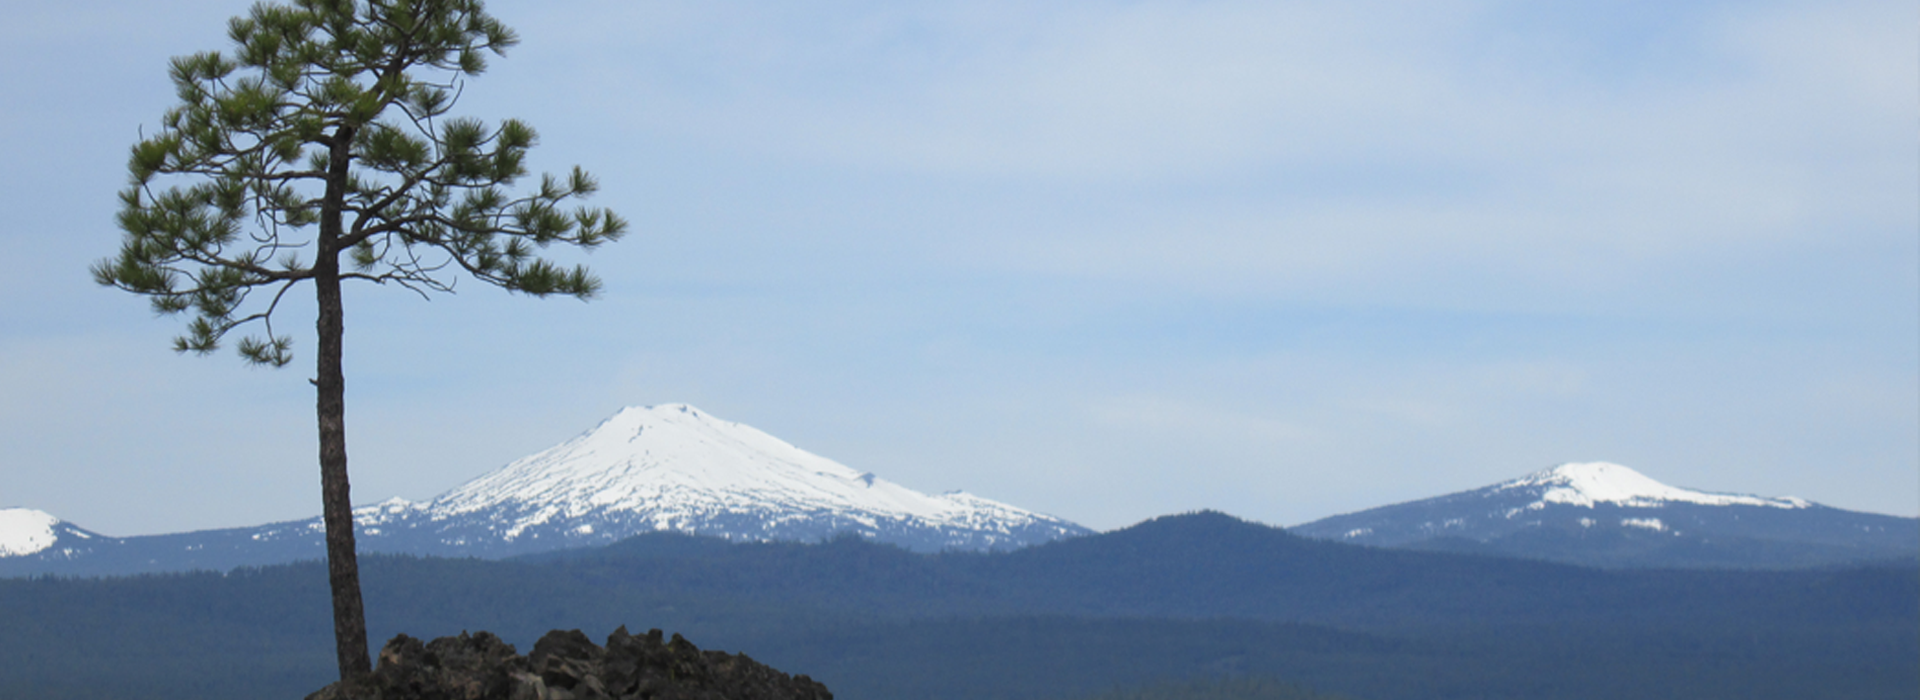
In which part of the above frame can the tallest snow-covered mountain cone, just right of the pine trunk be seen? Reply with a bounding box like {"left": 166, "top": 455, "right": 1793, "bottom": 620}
{"left": 332, "top": 405, "right": 1087, "bottom": 554}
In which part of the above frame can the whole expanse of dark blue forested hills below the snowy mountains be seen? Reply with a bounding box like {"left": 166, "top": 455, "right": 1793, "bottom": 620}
{"left": 0, "top": 514, "right": 1920, "bottom": 700}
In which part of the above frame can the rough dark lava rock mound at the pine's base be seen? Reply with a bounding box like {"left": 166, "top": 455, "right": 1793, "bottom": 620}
{"left": 307, "top": 627, "right": 833, "bottom": 700}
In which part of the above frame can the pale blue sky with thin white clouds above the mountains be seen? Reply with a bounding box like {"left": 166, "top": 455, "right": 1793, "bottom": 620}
{"left": 0, "top": 0, "right": 1920, "bottom": 535}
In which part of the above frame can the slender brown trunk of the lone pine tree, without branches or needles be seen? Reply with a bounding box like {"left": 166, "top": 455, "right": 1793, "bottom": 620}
{"left": 313, "top": 128, "right": 372, "bottom": 681}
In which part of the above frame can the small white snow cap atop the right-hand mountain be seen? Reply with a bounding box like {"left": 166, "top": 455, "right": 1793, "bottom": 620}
{"left": 1494, "top": 462, "right": 1811, "bottom": 508}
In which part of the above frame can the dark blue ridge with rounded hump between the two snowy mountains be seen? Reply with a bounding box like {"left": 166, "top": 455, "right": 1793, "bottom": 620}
{"left": 515, "top": 512, "right": 1920, "bottom": 627}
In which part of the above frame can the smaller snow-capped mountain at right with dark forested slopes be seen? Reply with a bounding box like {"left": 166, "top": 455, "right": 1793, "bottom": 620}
{"left": 1290, "top": 462, "right": 1920, "bottom": 568}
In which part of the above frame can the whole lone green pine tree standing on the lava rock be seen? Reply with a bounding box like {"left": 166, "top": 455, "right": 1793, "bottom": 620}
{"left": 92, "top": 0, "right": 626, "bottom": 679}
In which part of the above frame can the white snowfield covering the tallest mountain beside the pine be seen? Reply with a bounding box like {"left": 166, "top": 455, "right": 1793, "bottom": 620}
{"left": 355, "top": 403, "right": 1058, "bottom": 539}
